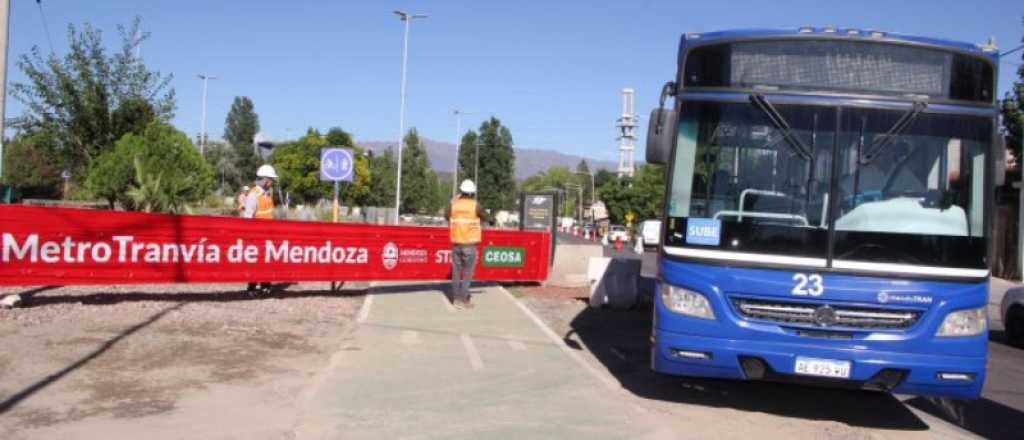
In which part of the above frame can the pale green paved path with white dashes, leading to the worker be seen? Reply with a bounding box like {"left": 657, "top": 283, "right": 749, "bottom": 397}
{"left": 295, "top": 284, "right": 650, "bottom": 439}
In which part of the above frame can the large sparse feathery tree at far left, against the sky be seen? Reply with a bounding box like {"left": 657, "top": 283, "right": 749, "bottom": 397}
{"left": 11, "top": 17, "right": 175, "bottom": 175}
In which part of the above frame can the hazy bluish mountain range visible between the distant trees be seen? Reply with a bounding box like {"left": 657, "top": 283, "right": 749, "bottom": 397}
{"left": 359, "top": 137, "right": 618, "bottom": 180}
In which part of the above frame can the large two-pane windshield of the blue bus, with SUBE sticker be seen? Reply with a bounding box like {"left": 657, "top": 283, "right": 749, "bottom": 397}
{"left": 666, "top": 99, "right": 991, "bottom": 268}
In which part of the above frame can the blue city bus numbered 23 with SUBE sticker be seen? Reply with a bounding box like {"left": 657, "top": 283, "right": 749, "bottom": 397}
{"left": 646, "top": 28, "right": 1006, "bottom": 398}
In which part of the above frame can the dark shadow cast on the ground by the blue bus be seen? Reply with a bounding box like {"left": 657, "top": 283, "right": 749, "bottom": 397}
{"left": 565, "top": 304, "right": 928, "bottom": 431}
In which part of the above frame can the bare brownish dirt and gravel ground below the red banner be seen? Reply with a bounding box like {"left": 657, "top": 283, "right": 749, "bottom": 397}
{"left": 0, "top": 283, "right": 366, "bottom": 440}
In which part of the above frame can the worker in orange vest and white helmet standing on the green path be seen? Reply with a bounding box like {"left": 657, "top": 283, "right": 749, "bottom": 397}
{"left": 447, "top": 179, "right": 484, "bottom": 310}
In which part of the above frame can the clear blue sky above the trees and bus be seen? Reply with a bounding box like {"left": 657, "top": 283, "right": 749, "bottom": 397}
{"left": 7, "top": 0, "right": 1024, "bottom": 160}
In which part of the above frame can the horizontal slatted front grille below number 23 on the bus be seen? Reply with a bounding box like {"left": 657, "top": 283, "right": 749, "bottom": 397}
{"left": 732, "top": 298, "right": 921, "bottom": 329}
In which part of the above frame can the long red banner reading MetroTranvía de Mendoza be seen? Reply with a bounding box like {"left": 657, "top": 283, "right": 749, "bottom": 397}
{"left": 0, "top": 205, "right": 551, "bottom": 285}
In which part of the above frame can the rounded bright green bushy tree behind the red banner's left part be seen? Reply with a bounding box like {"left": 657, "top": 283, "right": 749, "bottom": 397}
{"left": 86, "top": 121, "right": 213, "bottom": 212}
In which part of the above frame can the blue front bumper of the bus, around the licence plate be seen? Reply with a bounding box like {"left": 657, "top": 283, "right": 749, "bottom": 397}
{"left": 651, "top": 329, "right": 985, "bottom": 399}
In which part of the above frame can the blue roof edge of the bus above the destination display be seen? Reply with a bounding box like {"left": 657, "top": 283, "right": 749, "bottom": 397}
{"left": 679, "top": 27, "right": 999, "bottom": 62}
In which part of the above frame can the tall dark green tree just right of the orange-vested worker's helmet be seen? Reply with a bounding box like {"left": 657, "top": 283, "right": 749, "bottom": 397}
{"left": 474, "top": 117, "right": 516, "bottom": 211}
